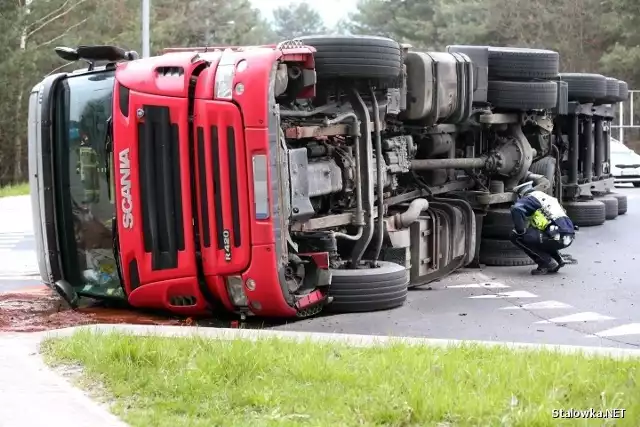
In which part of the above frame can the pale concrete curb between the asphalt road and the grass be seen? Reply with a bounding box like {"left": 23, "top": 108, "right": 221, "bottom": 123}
{"left": 36, "top": 324, "right": 640, "bottom": 359}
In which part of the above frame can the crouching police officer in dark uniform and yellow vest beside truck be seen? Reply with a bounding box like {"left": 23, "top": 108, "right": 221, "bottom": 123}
{"left": 511, "top": 181, "right": 575, "bottom": 275}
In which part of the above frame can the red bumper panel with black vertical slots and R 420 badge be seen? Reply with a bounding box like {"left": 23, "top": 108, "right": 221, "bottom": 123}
{"left": 194, "top": 100, "right": 252, "bottom": 276}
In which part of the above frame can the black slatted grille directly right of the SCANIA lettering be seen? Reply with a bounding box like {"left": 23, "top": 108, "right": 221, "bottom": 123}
{"left": 138, "top": 105, "right": 185, "bottom": 270}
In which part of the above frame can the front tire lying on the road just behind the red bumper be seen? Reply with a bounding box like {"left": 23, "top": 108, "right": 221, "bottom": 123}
{"left": 326, "top": 261, "right": 409, "bottom": 313}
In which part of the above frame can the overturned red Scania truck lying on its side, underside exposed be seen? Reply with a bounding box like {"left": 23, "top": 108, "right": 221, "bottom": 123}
{"left": 29, "top": 36, "right": 622, "bottom": 317}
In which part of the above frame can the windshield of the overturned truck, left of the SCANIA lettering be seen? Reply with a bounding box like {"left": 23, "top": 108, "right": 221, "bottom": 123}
{"left": 54, "top": 71, "right": 124, "bottom": 298}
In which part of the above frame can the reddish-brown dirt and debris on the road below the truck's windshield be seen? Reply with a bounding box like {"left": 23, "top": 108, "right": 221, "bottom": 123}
{"left": 0, "top": 288, "right": 192, "bottom": 332}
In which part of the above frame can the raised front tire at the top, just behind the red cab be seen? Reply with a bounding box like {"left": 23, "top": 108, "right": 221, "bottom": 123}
{"left": 297, "top": 36, "right": 402, "bottom": 81}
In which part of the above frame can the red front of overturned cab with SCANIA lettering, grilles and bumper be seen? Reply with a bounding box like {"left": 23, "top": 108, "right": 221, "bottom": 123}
{"left": 112, "top": 47, "right": 330, "bottom": 316}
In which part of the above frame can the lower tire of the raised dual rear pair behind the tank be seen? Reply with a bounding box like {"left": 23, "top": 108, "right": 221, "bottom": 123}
{"left": 487, "top": 80, "right": 558, "bottom": 111}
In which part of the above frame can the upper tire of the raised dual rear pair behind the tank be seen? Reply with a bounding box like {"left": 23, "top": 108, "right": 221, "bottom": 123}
{"left": 489, "top": 47, "right": 560, "bottom": 80}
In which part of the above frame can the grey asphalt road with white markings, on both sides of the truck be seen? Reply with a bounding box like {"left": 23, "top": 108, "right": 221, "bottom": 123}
{"left": 5, "top": 188, "right": 640, "bottom": 348}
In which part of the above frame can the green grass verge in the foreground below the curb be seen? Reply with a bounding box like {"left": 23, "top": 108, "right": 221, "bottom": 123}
{"left": 43, "top": 331, "right": 640, "bottom": 427}
